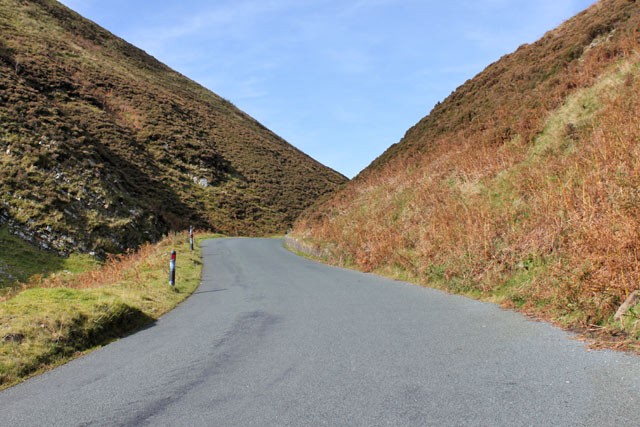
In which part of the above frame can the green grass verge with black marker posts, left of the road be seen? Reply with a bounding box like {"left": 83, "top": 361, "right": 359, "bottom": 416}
{"left": 0, "top": 234, "right": 214, "bottom": 389}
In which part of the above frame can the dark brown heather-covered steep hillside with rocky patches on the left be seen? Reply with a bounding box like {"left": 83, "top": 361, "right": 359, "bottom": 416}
{"left": 0, "top": 0, "right": 346, "bottom": 258}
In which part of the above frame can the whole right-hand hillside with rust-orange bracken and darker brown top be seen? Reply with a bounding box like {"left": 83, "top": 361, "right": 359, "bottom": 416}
{"left": 293, "top": 0, "right": 640, "bottom": 346}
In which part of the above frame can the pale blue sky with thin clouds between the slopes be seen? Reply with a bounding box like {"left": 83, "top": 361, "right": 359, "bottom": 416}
{"left": 62, "top": 0, "right": 595, "bottom": 177}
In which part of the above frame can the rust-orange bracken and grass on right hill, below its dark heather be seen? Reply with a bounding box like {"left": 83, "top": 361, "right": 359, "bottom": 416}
{"left": 291, "top": 50, "right": 640, "bottom": 353}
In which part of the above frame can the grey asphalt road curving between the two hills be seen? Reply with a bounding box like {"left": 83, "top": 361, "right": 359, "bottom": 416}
{"left": 0, "top": 239, "right": 640, "bottom": 427}
